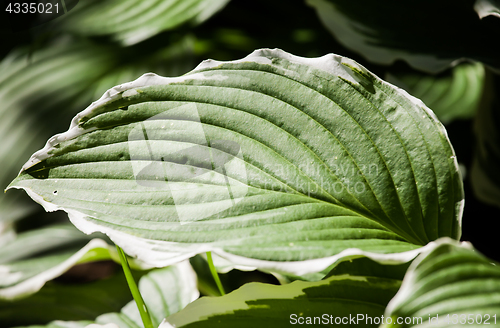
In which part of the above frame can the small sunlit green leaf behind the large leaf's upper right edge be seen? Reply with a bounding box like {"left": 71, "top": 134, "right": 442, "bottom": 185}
{"left": 387, "top": 63, "right": 485, "bottom": 124}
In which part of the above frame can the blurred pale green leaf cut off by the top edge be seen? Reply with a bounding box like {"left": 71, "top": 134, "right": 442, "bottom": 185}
{"left": 58, "top": 0, "right": 229, "bottom": 45}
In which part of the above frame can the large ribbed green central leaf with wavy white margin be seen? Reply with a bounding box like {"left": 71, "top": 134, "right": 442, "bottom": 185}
{"left": 10, "top": 50, "right": 463, "bottom": 274}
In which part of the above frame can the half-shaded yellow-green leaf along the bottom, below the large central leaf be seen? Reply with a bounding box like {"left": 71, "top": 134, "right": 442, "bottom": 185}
{"left": 160, "top": 262, "right": 401, "bottom": 328}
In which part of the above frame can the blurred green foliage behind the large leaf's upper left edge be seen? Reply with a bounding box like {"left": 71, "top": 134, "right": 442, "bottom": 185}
{"left": 0, "top": 36, "right": 194, "bottom": 228}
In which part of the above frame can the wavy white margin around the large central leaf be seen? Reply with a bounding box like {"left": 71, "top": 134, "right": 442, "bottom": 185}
{"left": 6, "top": 49, "right": 464, "bottom": 275}
